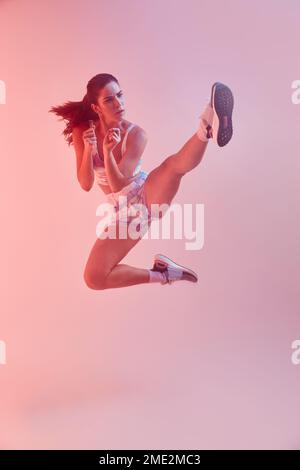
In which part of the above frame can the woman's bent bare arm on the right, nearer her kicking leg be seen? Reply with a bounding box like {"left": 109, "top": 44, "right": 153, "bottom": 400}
{"left": 103, "top": 127, "right": 147, "bottom": 192}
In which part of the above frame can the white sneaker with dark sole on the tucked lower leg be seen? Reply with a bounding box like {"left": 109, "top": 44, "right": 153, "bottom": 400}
{"left": 152, "top": 255, "right": 198, "bottom": 284}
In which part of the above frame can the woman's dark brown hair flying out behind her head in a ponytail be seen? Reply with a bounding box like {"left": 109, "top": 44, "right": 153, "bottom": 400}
{"left": 49, "top": 73, "right": 119, "bottom": 145}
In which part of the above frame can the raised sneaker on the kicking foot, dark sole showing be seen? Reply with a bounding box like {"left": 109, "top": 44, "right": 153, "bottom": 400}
{"left": 211, "top": 82, "right": 234, "bottom": 147}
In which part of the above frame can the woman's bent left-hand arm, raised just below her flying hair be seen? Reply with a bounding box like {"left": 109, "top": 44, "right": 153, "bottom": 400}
{"left": 72, "top": 126, "right": 94, "bottom": 191}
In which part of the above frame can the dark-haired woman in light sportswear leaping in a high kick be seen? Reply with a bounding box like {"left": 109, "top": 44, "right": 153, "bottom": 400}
{"left": 50, "top": 73, "right": 233, "bottom": 289}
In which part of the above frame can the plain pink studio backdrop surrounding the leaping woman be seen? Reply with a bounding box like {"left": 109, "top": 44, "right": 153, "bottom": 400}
{"left": 0, "top": 0, "right": 300, "bottom": 449}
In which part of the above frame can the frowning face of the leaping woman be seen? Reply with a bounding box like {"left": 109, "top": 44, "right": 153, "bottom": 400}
{"left": 94, "top": 82, "right": 125, "bottom": 123}
